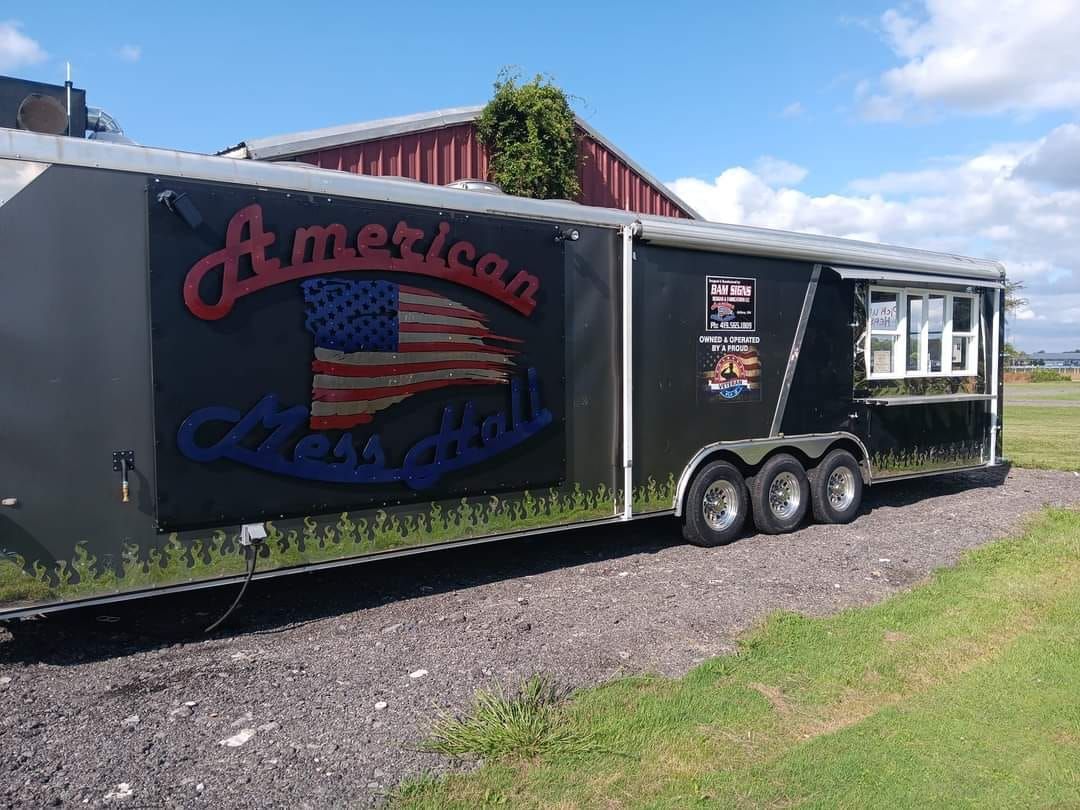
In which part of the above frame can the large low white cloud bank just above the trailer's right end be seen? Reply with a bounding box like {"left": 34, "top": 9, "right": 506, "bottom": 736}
{"left": 669, "top": 127, "right": 1080, "bottom": 350}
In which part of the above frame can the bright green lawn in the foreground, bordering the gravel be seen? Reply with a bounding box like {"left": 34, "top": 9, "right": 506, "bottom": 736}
{"left": 392, "top": 510, "right": 1080, "bottom": 809}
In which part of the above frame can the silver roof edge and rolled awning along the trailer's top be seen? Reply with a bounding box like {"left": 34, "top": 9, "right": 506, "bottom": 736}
{"left": 0, "top": 129, "right": 1004, "bottom": 281}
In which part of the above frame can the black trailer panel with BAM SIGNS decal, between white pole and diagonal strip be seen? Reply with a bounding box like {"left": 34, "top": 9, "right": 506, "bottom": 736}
{"left": 634, "top": 245, "right": 812, "bottom": 512}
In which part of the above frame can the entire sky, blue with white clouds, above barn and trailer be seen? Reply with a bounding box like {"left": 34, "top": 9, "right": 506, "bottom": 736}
{"left": 0, "top": 0, "right": 1080, "bottom": 349}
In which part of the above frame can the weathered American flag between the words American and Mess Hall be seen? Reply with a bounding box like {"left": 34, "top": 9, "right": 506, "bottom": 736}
{"left": 300, "top": 279, "right": 521, "bottom": 430}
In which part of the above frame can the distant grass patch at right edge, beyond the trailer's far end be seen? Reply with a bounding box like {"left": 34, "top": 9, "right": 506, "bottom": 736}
{"left": 1004, "top": 405, "right": 1080, "bottom": 470}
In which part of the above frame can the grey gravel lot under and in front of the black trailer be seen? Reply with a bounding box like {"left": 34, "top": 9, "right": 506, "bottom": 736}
{"left": 0, "top": 470, "right": 1080, "bottom": 808}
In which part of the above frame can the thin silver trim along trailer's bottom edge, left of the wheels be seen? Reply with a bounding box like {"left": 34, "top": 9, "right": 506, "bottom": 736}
{"left": 0, "top": 509, "right": 672, "bottom": 622}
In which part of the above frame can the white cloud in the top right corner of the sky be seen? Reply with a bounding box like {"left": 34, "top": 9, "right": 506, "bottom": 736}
{"left": 856, "top": 0, "right": 1080, "bottom": 121}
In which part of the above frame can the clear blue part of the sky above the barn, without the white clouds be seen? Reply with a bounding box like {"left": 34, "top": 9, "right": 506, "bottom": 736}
{"left": 4, "top": 2, "right": 1061, "bottom": 185}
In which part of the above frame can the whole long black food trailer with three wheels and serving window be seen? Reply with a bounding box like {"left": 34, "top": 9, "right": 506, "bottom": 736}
{"left": 0, "top": 130, "right": 1003, "bottom": 618}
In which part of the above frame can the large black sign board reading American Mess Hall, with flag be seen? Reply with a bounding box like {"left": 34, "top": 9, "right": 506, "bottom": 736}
{"left": 150, "top": 181, "right": 565, "bottom": 528}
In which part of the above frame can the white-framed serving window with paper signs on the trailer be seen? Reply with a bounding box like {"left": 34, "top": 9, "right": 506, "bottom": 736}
{"left": 866, "top": 286, "right": 978, "bottom": 380}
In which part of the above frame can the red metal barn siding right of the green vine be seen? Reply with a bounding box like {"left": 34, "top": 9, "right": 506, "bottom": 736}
{"left": 578, "top": 133, "right": 690, "bottom": 218}
